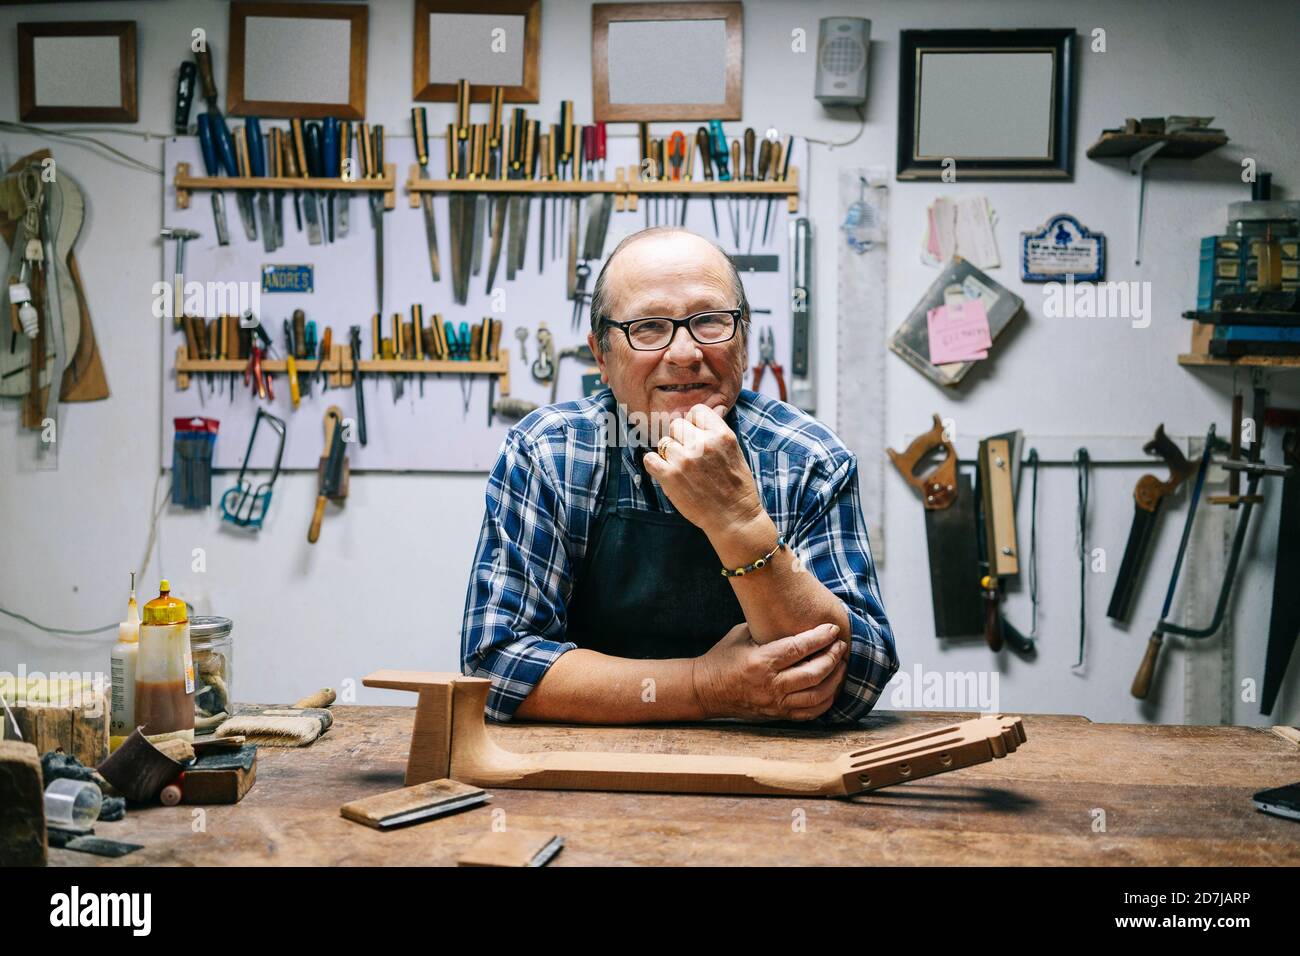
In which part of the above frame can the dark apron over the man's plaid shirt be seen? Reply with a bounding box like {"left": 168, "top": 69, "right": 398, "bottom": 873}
{"left": 566, "top": 410, "right": 745, "bottom": 659}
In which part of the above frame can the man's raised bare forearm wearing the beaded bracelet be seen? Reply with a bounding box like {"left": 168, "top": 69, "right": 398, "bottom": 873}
{"left": 709, "top": 512, "right": 852, "bottom": 644}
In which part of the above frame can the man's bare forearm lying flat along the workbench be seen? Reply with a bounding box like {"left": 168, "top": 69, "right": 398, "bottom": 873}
{"left": 515, "top": 648, "right": 710, "bottom": 723}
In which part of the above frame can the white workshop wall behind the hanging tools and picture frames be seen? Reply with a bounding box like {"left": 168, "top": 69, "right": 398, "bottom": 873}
{"left": 0, "top": 0, "right": 1300, "bottom": 723}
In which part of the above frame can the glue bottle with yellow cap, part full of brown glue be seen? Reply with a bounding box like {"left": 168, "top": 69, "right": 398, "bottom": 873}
{"left": 135, "top": 581, "right": 194, "bottom": 741}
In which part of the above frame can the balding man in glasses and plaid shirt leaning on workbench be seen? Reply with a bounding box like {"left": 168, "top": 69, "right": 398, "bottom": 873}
{"left": 462, "top": 228, "right": 898, "bottom": 723}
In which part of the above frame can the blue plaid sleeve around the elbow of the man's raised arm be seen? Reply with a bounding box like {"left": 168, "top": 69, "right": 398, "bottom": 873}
{"left": 790, "top": 451, "right": 898, "bottom": 723}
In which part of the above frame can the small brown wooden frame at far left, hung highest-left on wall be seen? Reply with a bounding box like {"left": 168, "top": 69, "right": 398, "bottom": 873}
{"left": 18, "top": 20, "right": 139, "bottom": 122}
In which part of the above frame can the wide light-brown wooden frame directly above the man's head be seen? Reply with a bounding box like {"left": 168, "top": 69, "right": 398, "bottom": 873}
{"left": 592, "top": 3, "right": 745, "bottom": 122}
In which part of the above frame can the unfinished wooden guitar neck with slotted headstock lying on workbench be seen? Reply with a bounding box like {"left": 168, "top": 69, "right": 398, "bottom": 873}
{"left": 361, "top": 671, "right": 1024, "bottom": 796}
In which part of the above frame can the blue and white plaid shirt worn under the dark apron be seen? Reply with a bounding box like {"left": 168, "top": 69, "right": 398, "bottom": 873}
{"left": 460, "top": 388, "right": 898, "bottom": 723}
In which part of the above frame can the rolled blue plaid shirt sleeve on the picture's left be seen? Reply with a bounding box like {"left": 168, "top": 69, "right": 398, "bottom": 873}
{"left": 460, "top": 431, "right": 577, "bottom": 721}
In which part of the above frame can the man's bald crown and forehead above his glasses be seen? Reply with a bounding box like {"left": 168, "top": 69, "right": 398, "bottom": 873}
{"left": 592, "top": 226, "right": 749, "bottom": 351}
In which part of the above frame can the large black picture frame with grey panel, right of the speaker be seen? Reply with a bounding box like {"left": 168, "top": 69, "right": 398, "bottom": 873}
{"left": 897, "top": 29, "right": 1075, "bottom": 179}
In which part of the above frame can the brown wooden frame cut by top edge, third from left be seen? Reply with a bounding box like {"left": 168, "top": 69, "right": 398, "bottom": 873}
{"left": 411, "top": 0, "right": 542, "bottom": 103}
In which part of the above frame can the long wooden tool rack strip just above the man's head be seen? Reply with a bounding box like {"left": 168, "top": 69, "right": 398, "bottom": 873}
{"left": 403, "top": 165, "right": 800, "bottom": 215}
